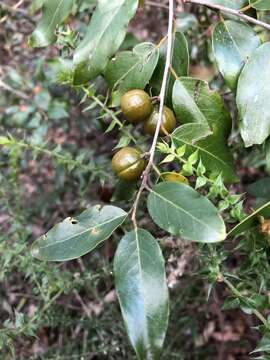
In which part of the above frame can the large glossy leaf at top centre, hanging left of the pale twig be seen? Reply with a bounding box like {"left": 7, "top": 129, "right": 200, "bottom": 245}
{"left": 73, "top": 0, "right": 138, "bottom": 85}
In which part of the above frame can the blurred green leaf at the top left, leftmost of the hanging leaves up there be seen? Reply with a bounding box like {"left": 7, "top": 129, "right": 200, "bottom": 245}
{"left": 29, "top": 0, "right": 73, "bottom": 47}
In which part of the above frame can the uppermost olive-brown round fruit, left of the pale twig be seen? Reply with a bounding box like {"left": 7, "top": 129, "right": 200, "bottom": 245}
{"left": 121, "top": 90, "right": 153, "bottom": 123}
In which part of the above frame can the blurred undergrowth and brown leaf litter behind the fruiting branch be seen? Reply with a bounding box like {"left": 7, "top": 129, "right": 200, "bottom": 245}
{"left": 0, "top": 0, "right": 270, "bottom": 360}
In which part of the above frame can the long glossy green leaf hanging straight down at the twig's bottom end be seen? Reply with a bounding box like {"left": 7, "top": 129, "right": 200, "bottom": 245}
{"left": 114, "top": 229, "right": 169, "bottom": 360}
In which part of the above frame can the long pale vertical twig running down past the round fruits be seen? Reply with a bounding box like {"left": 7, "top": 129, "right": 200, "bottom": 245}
{"left": 131, "top": 0, "right": 174, "bottom": 228}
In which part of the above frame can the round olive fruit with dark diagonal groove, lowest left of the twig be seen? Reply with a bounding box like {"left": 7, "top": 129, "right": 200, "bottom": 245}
{"left": 112, "top": 147, "right": 145, "bottom": 181}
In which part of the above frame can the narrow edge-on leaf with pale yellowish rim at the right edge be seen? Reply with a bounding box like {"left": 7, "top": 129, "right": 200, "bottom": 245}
{"left": 228, "top": 201, "right": 270, "bottom": 236}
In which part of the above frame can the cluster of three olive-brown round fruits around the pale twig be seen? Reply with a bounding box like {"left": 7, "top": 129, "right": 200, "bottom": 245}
{"left": 112, "top": 89, "right": 176, "bottom": 181}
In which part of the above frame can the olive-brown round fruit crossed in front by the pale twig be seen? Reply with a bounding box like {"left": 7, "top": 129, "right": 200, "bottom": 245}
{"left": 144, "top": 106, "right": 176, "bottom": 136}
